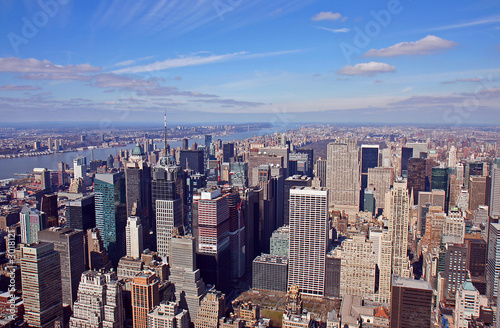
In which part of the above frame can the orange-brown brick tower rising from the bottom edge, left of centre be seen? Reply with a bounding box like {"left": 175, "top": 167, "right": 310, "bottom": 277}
{"left": 132, "top": 271, "right": 160, "bottom": 328}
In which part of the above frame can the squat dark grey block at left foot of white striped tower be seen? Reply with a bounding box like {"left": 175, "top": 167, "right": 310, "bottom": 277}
{"left": 252, "top": 254, "right": 288, "bottom": 292}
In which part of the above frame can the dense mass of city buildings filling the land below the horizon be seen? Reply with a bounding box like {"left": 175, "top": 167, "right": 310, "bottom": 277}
{"left": 0, "top": 125, "right": 500, "bottom": 328}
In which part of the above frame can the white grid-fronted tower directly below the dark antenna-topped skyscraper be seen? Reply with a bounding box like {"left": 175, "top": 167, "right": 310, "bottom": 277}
{"left": 156, "top": 198, "right": 182, "bottom": 258}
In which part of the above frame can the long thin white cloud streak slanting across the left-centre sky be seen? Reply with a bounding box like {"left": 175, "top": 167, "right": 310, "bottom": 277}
{"left": 113, "top": 50, "right": 300, "bottom": 74}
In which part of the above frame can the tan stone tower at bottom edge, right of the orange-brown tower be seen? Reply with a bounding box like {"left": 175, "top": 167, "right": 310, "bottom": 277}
{"left": 194, "top": 289, "right": 226, "bottom": 328}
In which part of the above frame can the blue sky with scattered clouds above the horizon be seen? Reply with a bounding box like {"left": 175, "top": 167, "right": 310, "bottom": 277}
{"left": 0, "top": 0, "right": 500, "bottom": 125}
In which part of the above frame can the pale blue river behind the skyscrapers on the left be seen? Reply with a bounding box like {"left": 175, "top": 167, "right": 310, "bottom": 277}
{"left": 0, "top": 126, "right": 292, "bottom": 180}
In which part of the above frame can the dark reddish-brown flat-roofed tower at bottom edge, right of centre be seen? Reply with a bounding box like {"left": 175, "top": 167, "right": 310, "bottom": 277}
{"left": 390, "top": 275, "right": 432, "bottom": 328}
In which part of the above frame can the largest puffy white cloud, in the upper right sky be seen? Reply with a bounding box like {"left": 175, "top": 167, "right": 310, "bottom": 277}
{"left": 363, "top": 35, "right": 458, "bottom": 57}
